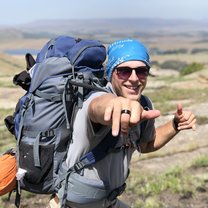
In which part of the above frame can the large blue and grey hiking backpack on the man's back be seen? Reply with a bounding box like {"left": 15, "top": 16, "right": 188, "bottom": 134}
{"left": 5, "top": 36, "right": 106, "bottom": 203}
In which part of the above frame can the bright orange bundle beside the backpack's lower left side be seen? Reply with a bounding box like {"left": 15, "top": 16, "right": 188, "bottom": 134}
{"left": 0, "top": 151, "right": 17, "bottom": 196}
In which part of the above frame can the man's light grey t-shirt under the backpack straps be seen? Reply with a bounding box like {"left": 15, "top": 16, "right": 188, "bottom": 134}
{"left": 66, "top": 82, "right": 155, "bottom": 206}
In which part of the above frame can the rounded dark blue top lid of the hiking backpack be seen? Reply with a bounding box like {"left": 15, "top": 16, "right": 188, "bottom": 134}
{"left": 36, "top": 36, "right": 106, "bottom": 71}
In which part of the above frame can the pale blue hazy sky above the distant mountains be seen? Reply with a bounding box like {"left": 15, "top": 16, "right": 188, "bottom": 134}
{"left": 0, "top": 0, "right": 208, "bottom": 26}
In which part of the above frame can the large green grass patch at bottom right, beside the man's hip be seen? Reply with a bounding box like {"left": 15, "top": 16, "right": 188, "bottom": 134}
{"left": 123, "top": 164, "right": 208, "bottom": 208}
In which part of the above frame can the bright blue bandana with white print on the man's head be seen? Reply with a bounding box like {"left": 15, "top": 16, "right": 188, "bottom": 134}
{"left": 106, "top": 39, "right": 150, "bottom": 81}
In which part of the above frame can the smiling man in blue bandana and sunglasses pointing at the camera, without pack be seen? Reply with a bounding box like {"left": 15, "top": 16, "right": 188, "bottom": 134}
{"left": 49, "top": 39, "right": 196, "bottom": 208}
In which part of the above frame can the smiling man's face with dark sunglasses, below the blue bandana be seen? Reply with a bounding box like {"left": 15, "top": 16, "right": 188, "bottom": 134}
{"left": 111, "top": 61, "right": 148, "bottom": 100}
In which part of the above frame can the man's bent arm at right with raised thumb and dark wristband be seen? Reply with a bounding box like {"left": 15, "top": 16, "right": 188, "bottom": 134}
{"left": 140, "top": 104, "right": 196, "bottom": 153}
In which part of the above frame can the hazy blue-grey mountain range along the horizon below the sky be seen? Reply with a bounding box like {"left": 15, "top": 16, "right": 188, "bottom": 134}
{"left": 0, "top": 18, "right": 208, "bottom": 41}
